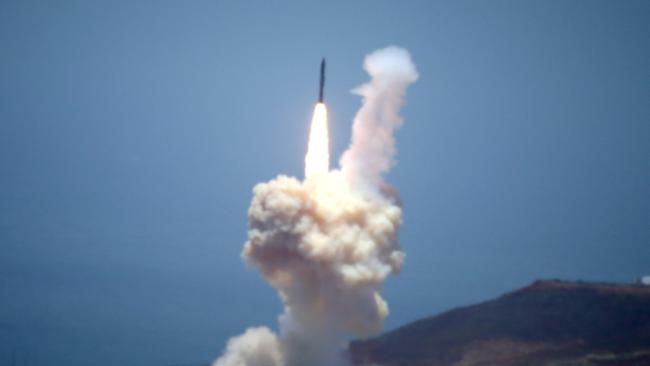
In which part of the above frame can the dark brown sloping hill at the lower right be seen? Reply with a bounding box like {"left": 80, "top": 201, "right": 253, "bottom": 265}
{"left": 351, "top": 281, "right": 650, "bottom": 366}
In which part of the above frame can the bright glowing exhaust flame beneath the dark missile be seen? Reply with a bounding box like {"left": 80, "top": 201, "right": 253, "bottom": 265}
{"left": 305, "top": 103, "right": 330, "bottom": 178}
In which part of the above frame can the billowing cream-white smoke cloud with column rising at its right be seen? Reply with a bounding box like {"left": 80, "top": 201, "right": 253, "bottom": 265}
{"left": 214, "top": 47, "right": 417, "bottom": 366}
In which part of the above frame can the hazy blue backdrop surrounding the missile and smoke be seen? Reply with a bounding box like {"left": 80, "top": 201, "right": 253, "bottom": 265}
{"left": 0, "top": 0, "right": 650, "bottom": 366}
